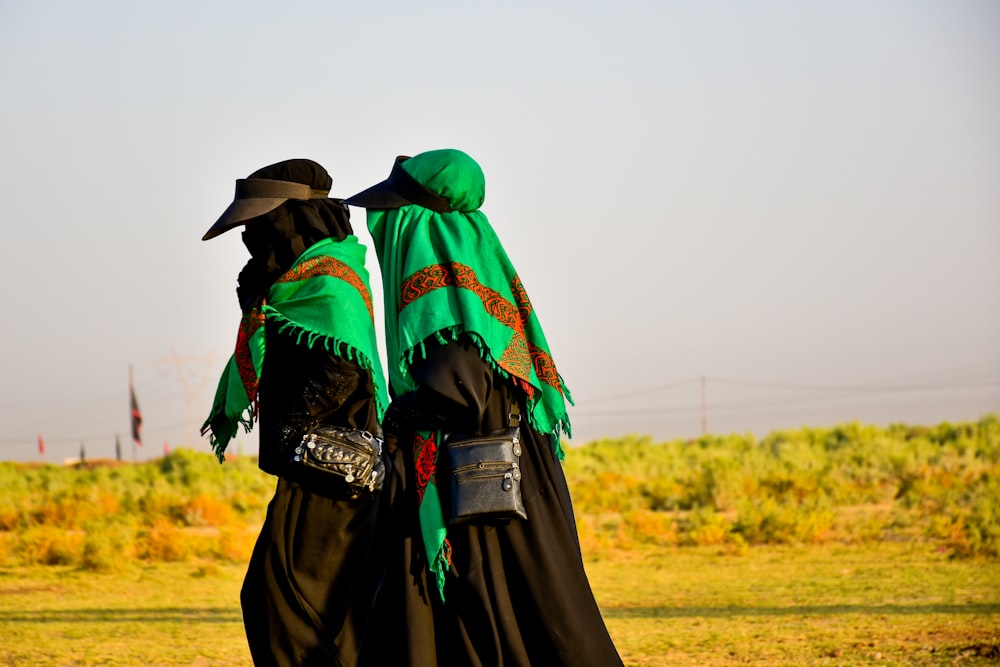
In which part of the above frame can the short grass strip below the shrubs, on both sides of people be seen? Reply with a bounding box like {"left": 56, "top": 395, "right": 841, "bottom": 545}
{"left": 0, "top": 543, "right": 1000, "bottom": 667}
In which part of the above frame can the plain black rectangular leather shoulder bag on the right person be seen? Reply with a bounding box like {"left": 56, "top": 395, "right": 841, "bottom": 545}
{"left": 442, "top": 402, "right": 528, "bottom": 525}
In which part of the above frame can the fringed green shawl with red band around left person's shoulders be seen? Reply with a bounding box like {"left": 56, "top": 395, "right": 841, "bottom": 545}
{"left": 202, "top": 236, "right": 386, "bottom": 462}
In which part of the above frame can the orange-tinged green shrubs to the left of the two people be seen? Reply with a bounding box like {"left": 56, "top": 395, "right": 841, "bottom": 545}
{"left": 0, "top": 449, "right": 274, "bottom": 571}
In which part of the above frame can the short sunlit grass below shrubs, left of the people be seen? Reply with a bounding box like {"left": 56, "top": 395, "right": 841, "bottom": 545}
{"left": 0, "top": 563, "right": 250, "bottom": 667}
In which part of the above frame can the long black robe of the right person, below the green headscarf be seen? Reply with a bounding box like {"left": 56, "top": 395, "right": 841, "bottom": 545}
{"left": 360, "top": 341, "right": 622, "bottom": 667}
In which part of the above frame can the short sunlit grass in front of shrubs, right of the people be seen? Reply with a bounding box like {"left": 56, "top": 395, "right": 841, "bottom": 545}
{"left": 588, "top": 544, "right": 1000, "bottom": 667}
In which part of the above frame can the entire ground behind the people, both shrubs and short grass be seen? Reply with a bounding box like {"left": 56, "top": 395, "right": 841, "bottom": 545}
{"left": 0, "top": 415, "right": 1000, "bottom": 667}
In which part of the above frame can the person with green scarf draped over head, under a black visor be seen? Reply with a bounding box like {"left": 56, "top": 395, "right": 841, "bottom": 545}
{"left": 344, "top": 149, "right": 621, "bottom": 667}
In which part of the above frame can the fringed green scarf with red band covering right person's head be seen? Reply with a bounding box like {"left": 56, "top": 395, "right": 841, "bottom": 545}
{"left": 368, "top": 149, "right": 572, "bottom": 446}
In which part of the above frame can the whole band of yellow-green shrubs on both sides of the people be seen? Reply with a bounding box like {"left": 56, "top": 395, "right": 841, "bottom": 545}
{"left": 0, "top": 415, "right": 1000, "bottom": 570}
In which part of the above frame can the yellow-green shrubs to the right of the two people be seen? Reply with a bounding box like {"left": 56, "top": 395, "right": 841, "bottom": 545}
{"left": 565, "top": 415, "right": 1000, "bottom": 558}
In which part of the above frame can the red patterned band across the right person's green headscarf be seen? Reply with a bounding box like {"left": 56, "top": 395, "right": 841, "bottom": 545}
{"left": 399, "top": 262, "right": 563, "bottom": 394}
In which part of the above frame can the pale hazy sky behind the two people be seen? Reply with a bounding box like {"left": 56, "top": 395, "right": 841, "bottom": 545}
{"left": 0, "top": 0, "right": 1000, "bottom": 461}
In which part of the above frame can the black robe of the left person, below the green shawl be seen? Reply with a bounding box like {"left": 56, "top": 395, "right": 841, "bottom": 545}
{"left": 240, "top": 323, "right": 381, "bottom": 667}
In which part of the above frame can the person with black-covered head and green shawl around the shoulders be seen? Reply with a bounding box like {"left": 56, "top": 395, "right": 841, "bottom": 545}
{"left": 202, "top": 159, "right": 387, "bottom": 667}
